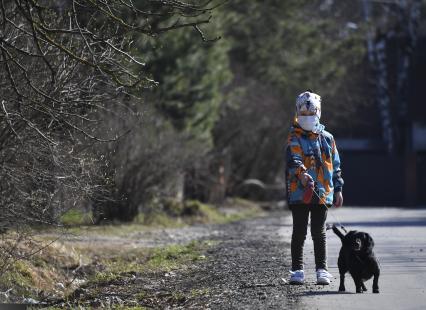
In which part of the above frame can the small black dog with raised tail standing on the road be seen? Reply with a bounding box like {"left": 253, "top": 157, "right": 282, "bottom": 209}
{"left": 333, "top": 225, "right": 380, "bottom": 293}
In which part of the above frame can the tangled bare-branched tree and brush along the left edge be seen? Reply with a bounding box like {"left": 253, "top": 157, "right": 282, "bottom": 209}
{"left": 0, "top": 0, "right": 220, "bottom": 272}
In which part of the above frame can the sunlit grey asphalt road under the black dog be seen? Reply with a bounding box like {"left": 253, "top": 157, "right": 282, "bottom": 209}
{"left": 280, "top": 207, "right": 426, "bottom": 310}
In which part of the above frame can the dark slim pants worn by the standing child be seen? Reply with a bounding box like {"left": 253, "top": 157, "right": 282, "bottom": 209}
{"left": 290, "top": 204, "right": 327, "bottom": 271}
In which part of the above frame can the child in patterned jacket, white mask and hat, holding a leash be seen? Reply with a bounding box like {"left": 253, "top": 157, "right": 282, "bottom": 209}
{"left": 286, "top": 90, "right": 343, "bottom": 285}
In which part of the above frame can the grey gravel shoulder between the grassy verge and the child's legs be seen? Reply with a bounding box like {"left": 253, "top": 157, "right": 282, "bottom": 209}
{"left": 162, "top": 212, "right": 297, "bottom": 309}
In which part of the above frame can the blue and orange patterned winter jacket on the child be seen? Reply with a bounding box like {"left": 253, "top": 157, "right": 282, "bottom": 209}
{"left": 286, "top": 122, "right": 344, "bottom": 205}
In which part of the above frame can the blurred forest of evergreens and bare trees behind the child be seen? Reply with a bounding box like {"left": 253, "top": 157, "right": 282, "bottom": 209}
{"left": 0, "top": 0, "right": 425, "bottom": 280}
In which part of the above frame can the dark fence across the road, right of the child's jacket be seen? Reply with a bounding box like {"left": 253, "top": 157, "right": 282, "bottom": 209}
{"left": 337, "top": 139, "right": 426, "bottom": 206}
